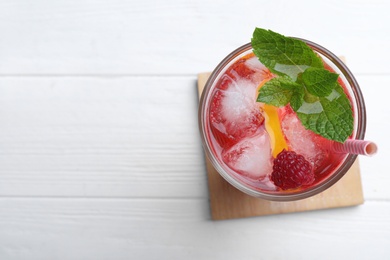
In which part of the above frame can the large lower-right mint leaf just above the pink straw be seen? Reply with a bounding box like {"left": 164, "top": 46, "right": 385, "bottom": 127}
{"left": 296, "top": 84, "right": 353, "bottom": 142}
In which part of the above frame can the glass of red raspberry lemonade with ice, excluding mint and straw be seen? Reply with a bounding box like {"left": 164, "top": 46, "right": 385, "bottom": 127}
{"left": 199, "top": 30, "right": 366, "bottom": 201}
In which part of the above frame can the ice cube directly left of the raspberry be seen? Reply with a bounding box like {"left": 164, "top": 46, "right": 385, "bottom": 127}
{"left": 222, "top": 128, "right": 273, "bottom": 180}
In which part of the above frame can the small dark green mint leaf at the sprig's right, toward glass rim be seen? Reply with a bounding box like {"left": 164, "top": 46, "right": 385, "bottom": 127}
{"left": 302, "top": 68, "right": 339, "bottom": 97}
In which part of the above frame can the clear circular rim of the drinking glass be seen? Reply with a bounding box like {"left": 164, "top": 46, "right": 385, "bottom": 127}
{"left": 198, "top": 40, "right": 366, "bottom": 201}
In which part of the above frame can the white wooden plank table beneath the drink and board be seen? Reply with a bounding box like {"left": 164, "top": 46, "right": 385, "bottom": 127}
{"left": 0, "top": 0, "right": 390, "bottom": 260}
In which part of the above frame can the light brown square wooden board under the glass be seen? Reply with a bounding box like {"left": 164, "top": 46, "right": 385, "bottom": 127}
{"left": 198, "top": 73, "right": 364, "bottom": 220}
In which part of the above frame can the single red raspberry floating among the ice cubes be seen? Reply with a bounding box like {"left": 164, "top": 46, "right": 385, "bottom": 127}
{"left": 271, "top": 150, "right": 314, "bottom": 190}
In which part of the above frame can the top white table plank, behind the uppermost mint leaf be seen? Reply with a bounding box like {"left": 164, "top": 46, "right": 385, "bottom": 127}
{"left": 0, "top": 0, "right": 390, "bottom": 75}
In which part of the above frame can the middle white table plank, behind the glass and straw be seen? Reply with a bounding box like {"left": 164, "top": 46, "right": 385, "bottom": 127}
{"left": 0, "top": 76, "right": 390, "bottom": 200}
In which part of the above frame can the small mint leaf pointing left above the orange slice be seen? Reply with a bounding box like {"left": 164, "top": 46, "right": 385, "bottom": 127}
{"left": 257, "top": 77, "right": 304, "bottom": 107}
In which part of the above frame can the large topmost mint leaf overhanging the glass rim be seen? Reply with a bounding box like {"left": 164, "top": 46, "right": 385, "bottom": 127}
{"left": 251, "top": 28, "right": 324, "bottom": 81}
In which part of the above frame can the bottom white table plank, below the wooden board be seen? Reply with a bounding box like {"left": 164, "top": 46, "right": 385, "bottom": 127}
{"left": 0, "top": 199, "right": 390, "bottom": 260}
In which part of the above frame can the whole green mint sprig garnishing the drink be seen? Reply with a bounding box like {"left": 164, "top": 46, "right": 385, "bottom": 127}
{"left": 251, "top": 28, "right": 353, "bottom": 142}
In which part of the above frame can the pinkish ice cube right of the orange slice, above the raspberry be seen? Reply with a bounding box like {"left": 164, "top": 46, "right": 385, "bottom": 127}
{"left": 282, "top": 110, "right": 327, "bottom": 168}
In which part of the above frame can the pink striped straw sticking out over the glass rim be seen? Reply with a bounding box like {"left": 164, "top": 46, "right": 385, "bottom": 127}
{"left": 332, "top": 140, "right": 378, "bottom": 156}
